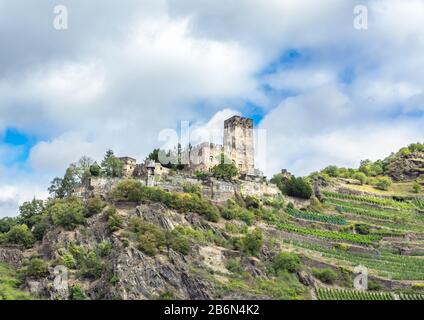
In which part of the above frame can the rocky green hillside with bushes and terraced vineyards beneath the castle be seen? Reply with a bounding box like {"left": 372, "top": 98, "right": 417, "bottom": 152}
{"left": 0, "top": 147, "right": 424, "bottom": 299}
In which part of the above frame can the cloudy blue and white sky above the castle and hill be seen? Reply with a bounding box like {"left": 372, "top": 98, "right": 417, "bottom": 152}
{"left": 0, "top": 0, "right": 424, "bottom": 217}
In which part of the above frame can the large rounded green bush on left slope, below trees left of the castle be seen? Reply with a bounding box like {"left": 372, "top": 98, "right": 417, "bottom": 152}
{"left": 47, "top": 197, "right": 85, "bottom": 230}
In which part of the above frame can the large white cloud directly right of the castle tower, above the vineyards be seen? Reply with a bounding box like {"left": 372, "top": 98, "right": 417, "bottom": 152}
{"left": 260, "top": 88, "right": 424, "bottom": 175}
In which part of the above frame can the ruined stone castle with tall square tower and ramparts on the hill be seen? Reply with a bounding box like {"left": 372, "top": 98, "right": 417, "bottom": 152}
{"left": 85, "top": 116, "right": 281, "bottom": 201}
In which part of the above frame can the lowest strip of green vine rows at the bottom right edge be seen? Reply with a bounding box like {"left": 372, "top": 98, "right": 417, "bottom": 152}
{"left": 316, "top": 289, "right": 394, "bottom": 300}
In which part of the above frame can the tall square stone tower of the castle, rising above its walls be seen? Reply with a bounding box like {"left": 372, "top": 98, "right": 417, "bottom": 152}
{"left": 224, "top": 116, "right": 255, "bottom": 174}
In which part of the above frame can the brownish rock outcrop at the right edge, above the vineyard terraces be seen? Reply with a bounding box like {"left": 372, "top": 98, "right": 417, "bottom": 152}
{"left": 388, "top": 152, "right": 424, "bottom": 181}
